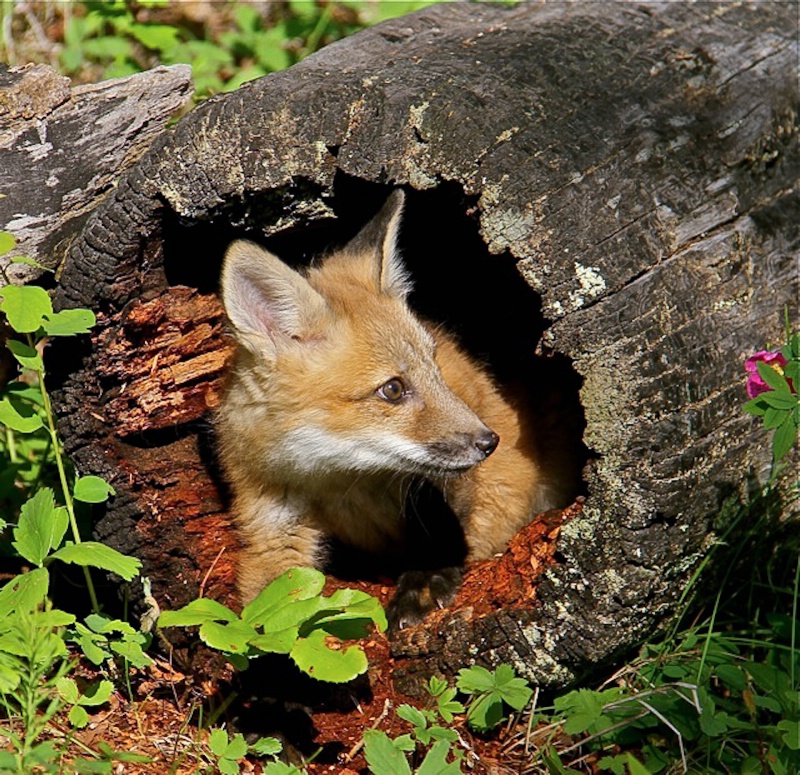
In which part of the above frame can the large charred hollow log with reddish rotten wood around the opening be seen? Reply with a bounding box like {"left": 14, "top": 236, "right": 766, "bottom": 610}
{"left": 48, "top": 2, "right": 800, "bottom": 690}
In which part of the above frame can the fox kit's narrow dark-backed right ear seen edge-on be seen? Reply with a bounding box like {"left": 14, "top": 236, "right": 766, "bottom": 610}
{"left": 346, "top": 188, "right": 411, "bottom": 299}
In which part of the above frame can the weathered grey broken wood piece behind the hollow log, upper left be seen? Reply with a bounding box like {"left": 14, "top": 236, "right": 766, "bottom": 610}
{"left": 0, "top": 65, "right": 192, "bottom": 282}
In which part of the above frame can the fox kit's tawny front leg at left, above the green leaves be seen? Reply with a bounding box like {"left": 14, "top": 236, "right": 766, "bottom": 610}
{"left": 234, "top": 496, "right": 323, "bottom": 605}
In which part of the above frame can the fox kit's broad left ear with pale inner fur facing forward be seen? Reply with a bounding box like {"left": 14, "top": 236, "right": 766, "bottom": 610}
{"left": 220, "top": 240, "right": 327, "bottom": 356}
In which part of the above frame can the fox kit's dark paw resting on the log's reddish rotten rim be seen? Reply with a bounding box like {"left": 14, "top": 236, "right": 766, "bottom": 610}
{"left": 386, "top": 568, "right": 461, "bottom": 633}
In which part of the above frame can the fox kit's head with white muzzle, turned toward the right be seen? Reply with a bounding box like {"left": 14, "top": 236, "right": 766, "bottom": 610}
{"left": 216, "top": 190, "right": 498, "bottom": 476}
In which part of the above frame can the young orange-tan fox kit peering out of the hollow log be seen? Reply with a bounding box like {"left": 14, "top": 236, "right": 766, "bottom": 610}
{"left": 212, "top": 190, "right": 573, "bottom": 627}
